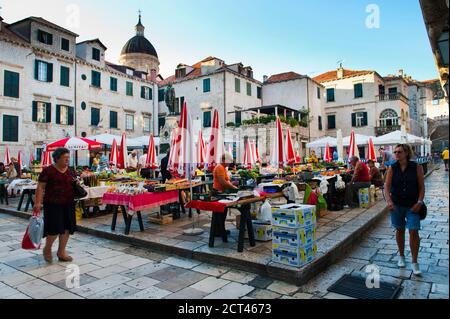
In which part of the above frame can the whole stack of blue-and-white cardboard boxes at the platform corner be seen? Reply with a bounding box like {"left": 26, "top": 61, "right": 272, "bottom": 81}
{"left": 272, "top": 204, "right": 317, "bottom": 267}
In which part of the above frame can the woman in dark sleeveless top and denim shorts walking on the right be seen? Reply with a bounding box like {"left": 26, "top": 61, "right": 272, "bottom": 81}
{"left": 384, "top": 144, "right": 425, "bottom": 275}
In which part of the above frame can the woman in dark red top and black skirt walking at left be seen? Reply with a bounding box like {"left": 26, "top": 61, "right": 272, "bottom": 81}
{"left": 33, "top": 148, "right": 77, "bottom": 263}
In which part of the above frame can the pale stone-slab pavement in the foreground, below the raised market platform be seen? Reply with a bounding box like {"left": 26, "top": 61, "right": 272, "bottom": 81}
{"left": 0, "top": 168, "right": 449, "bottom": 299}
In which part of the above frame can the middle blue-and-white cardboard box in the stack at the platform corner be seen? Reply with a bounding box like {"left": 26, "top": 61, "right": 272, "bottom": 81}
{"left": 272, "top": 225, "right": 316, "bottom": 249}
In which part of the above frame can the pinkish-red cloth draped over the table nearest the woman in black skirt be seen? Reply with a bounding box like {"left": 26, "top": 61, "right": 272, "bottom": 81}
{"left": 103, "top": 190, "right": 179, "bottom": 212}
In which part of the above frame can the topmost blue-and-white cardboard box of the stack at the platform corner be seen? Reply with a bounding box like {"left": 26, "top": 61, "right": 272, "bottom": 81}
{"left": 272, "top": 204, "right": 317, "bottom": 228}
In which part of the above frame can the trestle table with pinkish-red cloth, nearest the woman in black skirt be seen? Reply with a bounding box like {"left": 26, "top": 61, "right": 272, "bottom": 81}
{"left": 102, "top": 190, "right": 179, "bottom": 235}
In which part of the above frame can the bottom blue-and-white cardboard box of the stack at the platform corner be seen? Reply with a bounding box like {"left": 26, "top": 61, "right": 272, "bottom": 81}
{"left": 272, "top": 244, "right": 317, "bottom": 267}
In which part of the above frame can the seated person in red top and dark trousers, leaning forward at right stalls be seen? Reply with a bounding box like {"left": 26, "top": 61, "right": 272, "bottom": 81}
{"left": 345, "top": 156, "right": 370, "bottom": 208}
